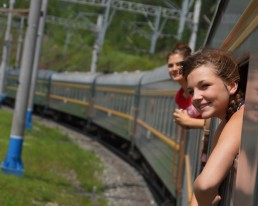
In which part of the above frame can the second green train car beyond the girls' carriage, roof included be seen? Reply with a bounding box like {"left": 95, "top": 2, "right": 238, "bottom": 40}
{"left": 92, "top": 72, "right": 143, "bottom": 141}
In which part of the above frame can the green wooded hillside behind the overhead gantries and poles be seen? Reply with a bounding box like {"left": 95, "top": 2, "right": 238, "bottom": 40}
{"left": 2, "top": 0, "right": 216, "bottom": 71}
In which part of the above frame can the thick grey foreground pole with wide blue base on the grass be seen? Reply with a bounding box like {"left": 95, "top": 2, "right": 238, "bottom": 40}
{"left": 1, "top": 0, "right": 42, "bottom": 176}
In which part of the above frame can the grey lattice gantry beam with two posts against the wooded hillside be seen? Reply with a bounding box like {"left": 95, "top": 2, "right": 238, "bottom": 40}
{"left": 61, "top": 0, "right": 186, "bottom": 69}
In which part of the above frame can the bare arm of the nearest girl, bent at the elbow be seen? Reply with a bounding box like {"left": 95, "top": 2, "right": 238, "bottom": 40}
{"left": 194, "top": 109, "right": 244, "bottom": 206}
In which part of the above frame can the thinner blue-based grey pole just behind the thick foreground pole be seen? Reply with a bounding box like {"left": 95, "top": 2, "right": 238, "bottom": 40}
{"left": 25, "top": 0, "right": 48, "bottom": 129}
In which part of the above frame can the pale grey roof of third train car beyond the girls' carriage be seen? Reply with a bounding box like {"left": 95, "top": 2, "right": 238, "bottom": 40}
{"left": 52, "top": 72, "right": 101, "bottom": 84}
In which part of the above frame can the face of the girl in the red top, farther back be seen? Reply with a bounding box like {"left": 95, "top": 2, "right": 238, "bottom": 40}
{"left": 168, "top": 54, "right": 184, "bottom": 82}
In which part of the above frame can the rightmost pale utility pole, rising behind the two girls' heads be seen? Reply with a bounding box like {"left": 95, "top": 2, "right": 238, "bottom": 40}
{"left": 189, "top": 0, "right": 202, "bottom": 51}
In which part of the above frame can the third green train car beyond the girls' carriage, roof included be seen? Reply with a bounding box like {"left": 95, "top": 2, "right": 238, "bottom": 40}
{"left": 49, "top": 72, "right": 100, "bottom": 120}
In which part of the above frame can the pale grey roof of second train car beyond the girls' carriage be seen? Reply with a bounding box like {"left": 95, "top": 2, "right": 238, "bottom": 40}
{"left": 96, "top": 71, "right": 146, "bottom": 86}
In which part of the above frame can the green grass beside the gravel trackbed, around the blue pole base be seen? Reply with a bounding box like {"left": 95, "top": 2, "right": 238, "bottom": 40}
{"left": 0, "top": 110, "right": 107, "bottom": 206}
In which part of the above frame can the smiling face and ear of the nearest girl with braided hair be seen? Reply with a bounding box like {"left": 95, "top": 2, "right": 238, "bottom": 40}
{"left": 187, "top": 65, "right": 237, "bottom": 120}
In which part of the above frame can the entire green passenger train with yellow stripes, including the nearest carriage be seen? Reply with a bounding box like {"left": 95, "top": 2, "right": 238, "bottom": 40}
{"left": 2, "top": 0, "right": 258, "bottom": 206}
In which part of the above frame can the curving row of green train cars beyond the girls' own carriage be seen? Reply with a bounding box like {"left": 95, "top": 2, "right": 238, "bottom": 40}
{"left": 5, "top": 66, "right": 202, "bottom": 204}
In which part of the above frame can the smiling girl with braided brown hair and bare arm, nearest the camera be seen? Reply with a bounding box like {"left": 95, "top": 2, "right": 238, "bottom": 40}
{"left": 182, "top": 50, "right": 244, "bottom": 206}
